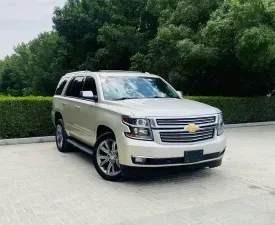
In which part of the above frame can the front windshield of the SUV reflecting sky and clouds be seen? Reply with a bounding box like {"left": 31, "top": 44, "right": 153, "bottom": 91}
{"left": 101, "top": 76, "right": 178, "bottom": 100}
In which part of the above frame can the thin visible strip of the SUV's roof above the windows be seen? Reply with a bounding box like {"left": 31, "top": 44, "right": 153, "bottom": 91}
{"left": 64, "top": 70, "right": 158, "bottom": 77}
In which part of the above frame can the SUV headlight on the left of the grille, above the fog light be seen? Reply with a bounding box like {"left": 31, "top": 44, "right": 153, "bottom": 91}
{"left": 122, "top": 116, "right": 153, "bottom": 141}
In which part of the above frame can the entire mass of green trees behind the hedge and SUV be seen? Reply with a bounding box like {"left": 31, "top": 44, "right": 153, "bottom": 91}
{"left": 0, "top": 0, "right": 275, "bottom": 97}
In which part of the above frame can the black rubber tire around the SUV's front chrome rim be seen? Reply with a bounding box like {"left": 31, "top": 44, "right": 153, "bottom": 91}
{"left": 93, "top": 133, "right": 122, "bottom": 181}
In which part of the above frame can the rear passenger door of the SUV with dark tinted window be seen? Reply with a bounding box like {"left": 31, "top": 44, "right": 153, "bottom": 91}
{"left": 63, "top": 76, "right": 84, "bottom": 137}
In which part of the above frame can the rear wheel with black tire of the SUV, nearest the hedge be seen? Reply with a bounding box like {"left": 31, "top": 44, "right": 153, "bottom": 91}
{"left": 55, "top": 119, "right": 72, "bottom": 152}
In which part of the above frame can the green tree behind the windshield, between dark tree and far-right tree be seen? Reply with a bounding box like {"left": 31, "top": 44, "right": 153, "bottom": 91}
{"left": 132, "top": 0, "right": 220, "bottom": 94}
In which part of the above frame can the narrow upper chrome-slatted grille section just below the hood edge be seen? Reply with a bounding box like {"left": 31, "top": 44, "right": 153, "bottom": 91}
{"left": 156, "top": 116, "right": 216, "bottom": 126}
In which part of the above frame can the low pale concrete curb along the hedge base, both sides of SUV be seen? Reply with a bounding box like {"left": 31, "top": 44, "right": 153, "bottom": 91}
{"left": 0, "top": 121, "right": 275, "bottom": 146}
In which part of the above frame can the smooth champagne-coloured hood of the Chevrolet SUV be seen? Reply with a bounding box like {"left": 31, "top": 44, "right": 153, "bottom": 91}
{"left": 106, "top": 99, "right": 220, "bottom": 117}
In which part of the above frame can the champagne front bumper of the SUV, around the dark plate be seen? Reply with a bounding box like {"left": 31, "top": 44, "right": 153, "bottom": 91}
{"left": 117, "top": 134, "right": 226, "bottom": 167}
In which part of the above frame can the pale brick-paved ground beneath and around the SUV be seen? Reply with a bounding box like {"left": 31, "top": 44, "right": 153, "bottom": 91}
{"left": 0, "top": 126, "right": 275, "bottom": 225}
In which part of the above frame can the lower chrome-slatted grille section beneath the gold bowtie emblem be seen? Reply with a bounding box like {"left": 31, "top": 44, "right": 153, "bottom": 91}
{"left": 160, "top": 128, "right": 215, "bottom": 143}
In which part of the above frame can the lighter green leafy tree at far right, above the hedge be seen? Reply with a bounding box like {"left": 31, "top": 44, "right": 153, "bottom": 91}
{"left": 202, "top": 0, "right": 275, "bottom": 96}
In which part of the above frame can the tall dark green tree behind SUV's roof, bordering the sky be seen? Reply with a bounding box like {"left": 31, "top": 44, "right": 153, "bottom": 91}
{"left": 53, "top": 0, "right": 156, "bottom": 71}
